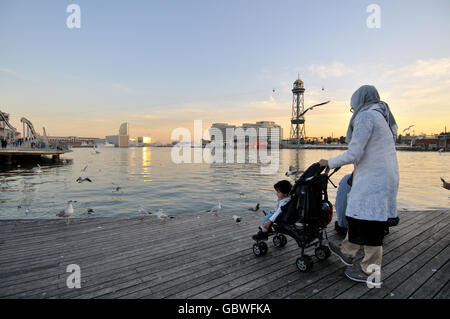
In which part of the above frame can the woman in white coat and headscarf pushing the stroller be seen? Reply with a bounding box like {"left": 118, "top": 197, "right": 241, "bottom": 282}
{"left": 320, "top": 85, "right": 399, "bottom": 282}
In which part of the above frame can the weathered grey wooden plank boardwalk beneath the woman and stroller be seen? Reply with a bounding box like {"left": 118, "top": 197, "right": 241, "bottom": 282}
{"left": 0, "top": 211, "right": 450, "bottom": 299}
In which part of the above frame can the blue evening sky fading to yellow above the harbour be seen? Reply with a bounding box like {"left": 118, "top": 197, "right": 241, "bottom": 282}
{"left": 0, "top": 0, "right": 450, "bottom": 142}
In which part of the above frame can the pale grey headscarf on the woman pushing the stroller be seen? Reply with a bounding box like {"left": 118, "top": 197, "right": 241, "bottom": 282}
{"left": 345, "top": 85, "right": 398, "bottom": 143}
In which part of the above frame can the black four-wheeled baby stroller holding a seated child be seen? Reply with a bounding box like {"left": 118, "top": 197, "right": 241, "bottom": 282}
{"left": 253, "top": 163, "right": 340, "bottom": 272}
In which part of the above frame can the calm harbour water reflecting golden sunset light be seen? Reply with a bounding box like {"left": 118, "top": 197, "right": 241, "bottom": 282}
{"left": 0, "top": 148, "right": 450, "bottom": 219}
